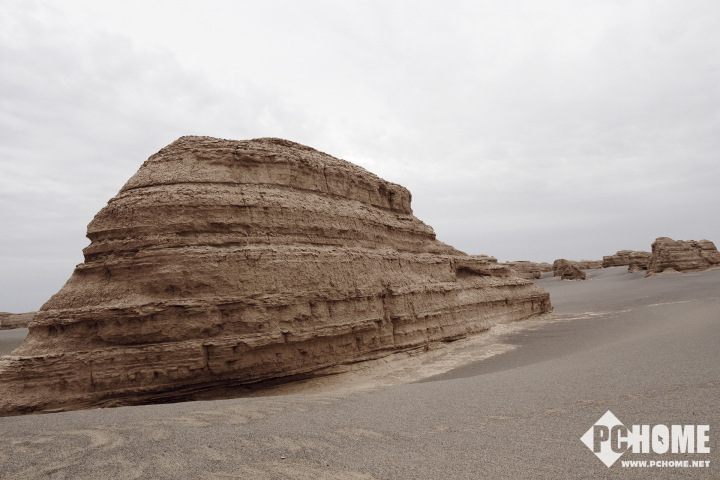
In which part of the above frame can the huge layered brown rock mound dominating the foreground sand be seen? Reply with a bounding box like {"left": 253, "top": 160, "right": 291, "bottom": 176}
{"left": 0, "top": 137, "right": 552, "bottom": 415}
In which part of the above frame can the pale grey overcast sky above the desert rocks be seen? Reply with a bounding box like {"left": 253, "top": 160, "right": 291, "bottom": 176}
{"left": 0, "top": 0, "right": 720, "bottom": 312}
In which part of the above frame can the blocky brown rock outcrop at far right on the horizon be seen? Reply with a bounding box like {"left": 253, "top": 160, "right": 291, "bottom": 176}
{"left": 645, "top": 237, "right": 720, "bottom": 277}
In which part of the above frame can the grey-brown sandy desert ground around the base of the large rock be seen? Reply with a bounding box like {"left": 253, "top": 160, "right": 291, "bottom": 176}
{"left": 0, "top": 267, "right": 720, "bottom": 479}
